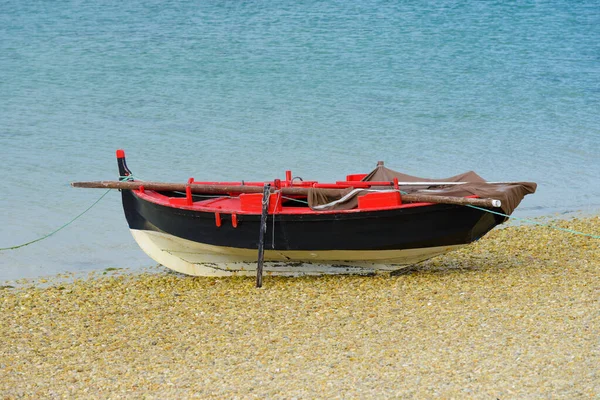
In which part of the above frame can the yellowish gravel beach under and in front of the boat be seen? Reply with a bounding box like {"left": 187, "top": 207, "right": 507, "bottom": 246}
{"left": 0, "top": 217, "right": 600, "bottom": 399}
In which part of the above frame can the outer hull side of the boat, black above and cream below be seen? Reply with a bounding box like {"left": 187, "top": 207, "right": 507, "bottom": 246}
{"left": 122, "top": 190, "right": 502, "bottom": 276}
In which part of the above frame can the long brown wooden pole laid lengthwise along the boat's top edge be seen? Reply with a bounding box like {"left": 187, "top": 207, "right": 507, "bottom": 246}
{"left": 71, "top": 181, "right": 502, "bottom": 208}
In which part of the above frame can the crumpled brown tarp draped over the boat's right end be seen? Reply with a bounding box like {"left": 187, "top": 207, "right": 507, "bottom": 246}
{"left": 308, "top": 165, "right": 537, "bottom": 215}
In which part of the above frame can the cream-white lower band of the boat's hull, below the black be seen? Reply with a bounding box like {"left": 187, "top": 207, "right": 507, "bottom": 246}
{"left": 131, "top": 229, "right": 464, "bottom": 276}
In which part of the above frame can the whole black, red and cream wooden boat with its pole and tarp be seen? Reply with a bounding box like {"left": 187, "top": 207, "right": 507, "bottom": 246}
{"left": 72, "top": 150, "right": 535, "bottom": 276}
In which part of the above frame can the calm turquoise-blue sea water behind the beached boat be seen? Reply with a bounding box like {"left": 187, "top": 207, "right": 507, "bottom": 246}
{"left": 0, "top": 0, "right": 600, "bottom": 280}
